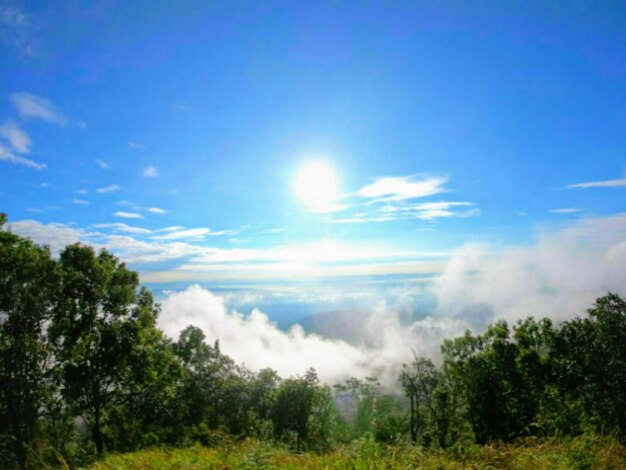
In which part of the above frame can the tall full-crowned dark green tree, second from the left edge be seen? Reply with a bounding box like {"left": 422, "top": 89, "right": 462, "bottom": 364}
{"left": 50, "top": 244, "right": 158, "bottom": 455}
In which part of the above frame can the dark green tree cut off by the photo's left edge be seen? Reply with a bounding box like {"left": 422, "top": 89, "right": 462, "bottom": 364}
{"left": 0, "top": 214, "right": 58, "bottom": 468}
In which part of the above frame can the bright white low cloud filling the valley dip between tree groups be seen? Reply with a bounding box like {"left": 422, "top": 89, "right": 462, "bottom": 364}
{"left": 159, "top": 286, "right": 466, "bottom": 388}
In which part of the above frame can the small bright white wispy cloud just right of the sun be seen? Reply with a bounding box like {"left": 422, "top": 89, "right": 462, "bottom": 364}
{"left": 357, "top": 176, "right": 448, "bottom": 202}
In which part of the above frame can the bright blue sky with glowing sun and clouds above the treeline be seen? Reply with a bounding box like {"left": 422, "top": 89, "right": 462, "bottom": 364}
{"left": 0, "top": 0, "right": 626, "bottom": 380}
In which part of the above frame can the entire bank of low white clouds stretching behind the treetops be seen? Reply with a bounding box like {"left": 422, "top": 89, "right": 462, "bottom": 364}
{"left": 160, "top": 214, "right": 626, "bottom": 387}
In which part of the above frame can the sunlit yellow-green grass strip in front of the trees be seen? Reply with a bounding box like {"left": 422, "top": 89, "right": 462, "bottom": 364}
{"left": 84, "top": 436, "right": 626, "bottom": 470}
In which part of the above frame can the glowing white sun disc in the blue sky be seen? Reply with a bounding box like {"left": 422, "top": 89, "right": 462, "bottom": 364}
{"left": 294, "top": 161, "right": 338, "bottom": 212}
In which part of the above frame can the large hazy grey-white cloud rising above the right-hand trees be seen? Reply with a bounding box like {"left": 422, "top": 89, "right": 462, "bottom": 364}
{"left": 434, "top": 213, "right": 626, "bottom": 321}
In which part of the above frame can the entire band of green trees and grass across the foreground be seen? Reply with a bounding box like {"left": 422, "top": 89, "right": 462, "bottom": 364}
{"left": 0, "top": 215, "right": 626, "bottom": 469}
